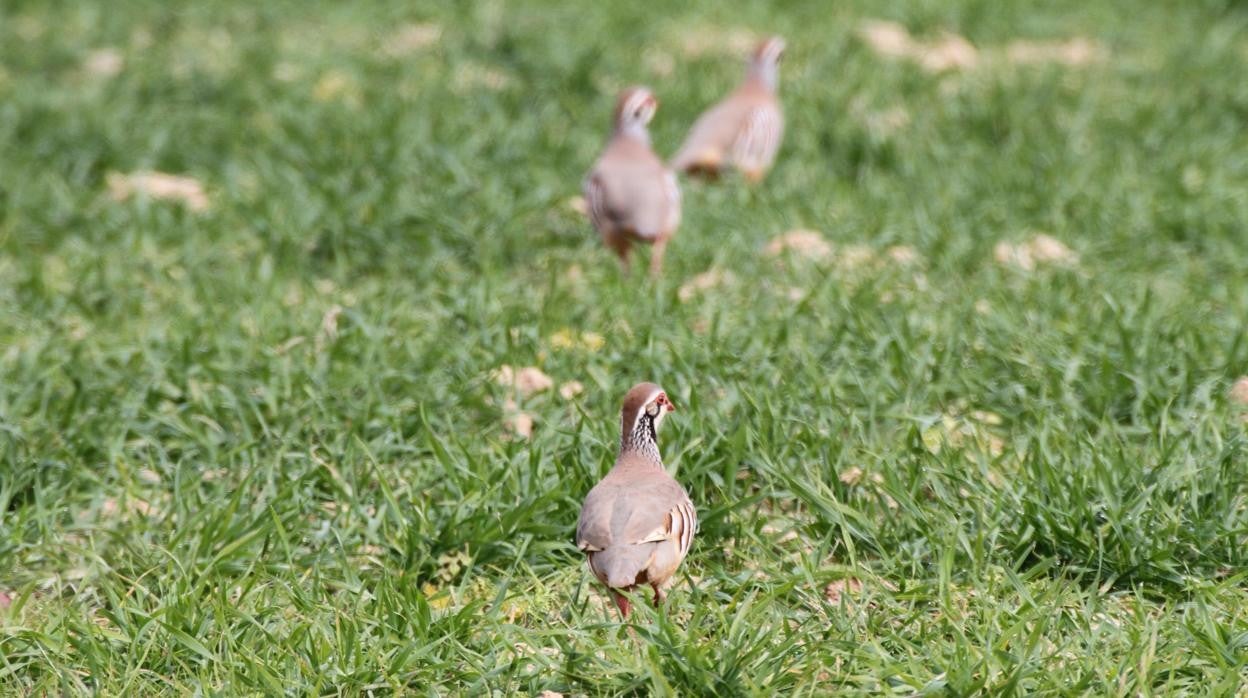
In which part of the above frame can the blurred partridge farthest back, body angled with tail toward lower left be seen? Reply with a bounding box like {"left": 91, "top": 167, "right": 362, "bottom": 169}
{"left": 671, "top": 36, "right": 785, "bottom": 182}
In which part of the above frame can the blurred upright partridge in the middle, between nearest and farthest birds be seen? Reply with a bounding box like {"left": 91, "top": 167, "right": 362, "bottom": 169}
{"left": 584, "top": 87, "right": 680, "bottom": 275}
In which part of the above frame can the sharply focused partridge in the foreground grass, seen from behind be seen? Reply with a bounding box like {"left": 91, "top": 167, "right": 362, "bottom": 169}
{"left": 577, "top": 383, "right": 698, "bottom": 618}
